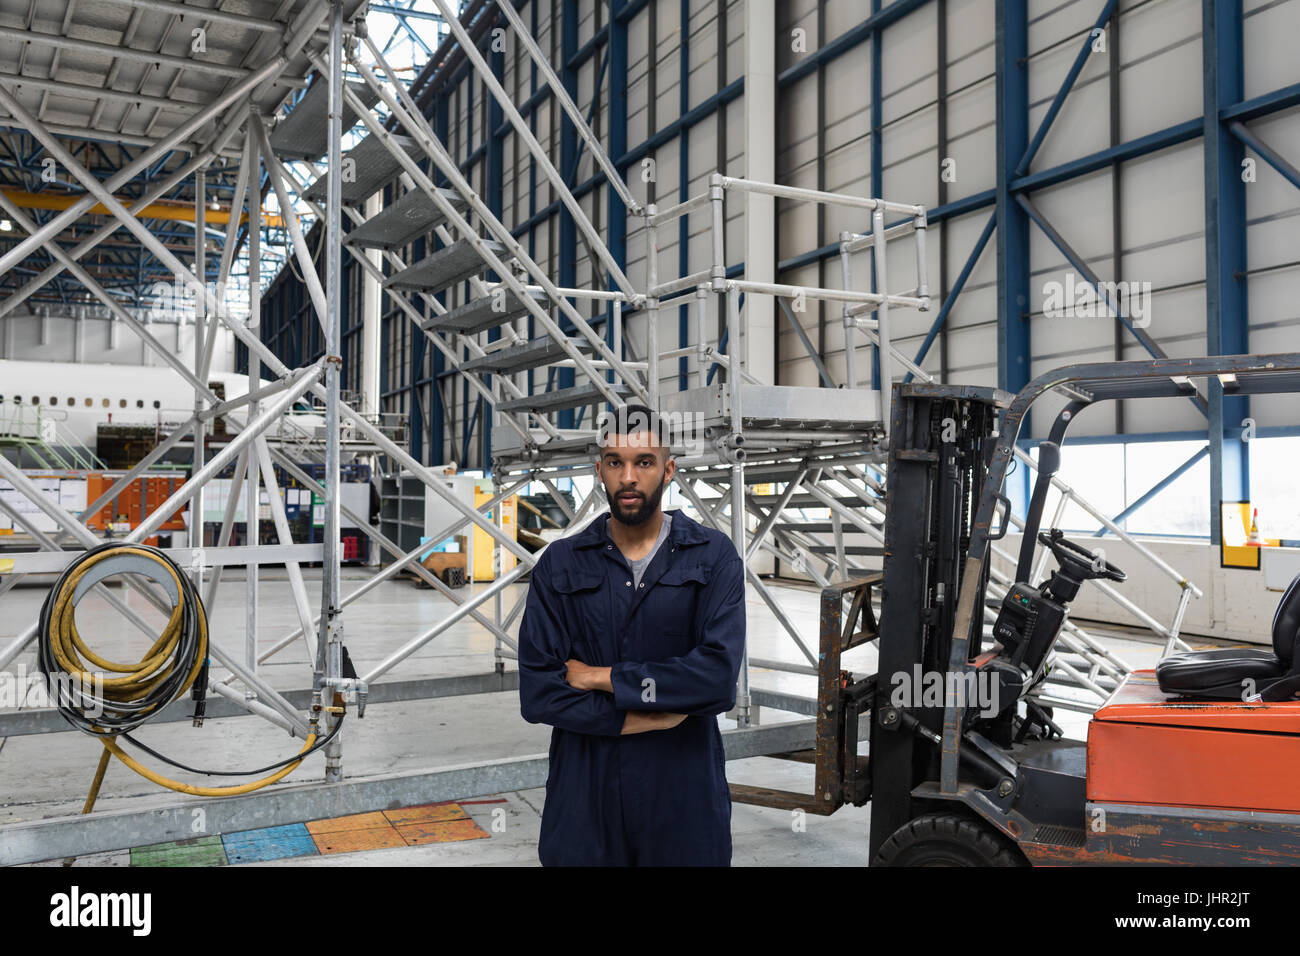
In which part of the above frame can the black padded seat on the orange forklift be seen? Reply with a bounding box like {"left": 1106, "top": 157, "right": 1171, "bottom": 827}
{"left": 1156, "top": 575, "right": 1300, "bottom": 700}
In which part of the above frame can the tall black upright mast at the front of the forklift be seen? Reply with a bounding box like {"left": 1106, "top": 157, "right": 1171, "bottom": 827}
{"left": 871, "top": 384, "right": 1011, "bottom": 856}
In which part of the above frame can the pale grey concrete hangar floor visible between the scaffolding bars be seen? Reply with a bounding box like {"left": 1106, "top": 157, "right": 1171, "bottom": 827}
{"left": 0, "top": 568, "right": 1175, "bottom": 866}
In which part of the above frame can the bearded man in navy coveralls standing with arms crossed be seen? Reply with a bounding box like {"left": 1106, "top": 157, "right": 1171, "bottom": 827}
{"left": 519, "top": 405, "right": 745, "bottom": 866}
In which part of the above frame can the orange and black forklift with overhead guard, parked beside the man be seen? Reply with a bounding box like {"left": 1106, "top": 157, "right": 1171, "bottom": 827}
{"left": 764, "top": 352, "right": 1300, "bottom": 866}
